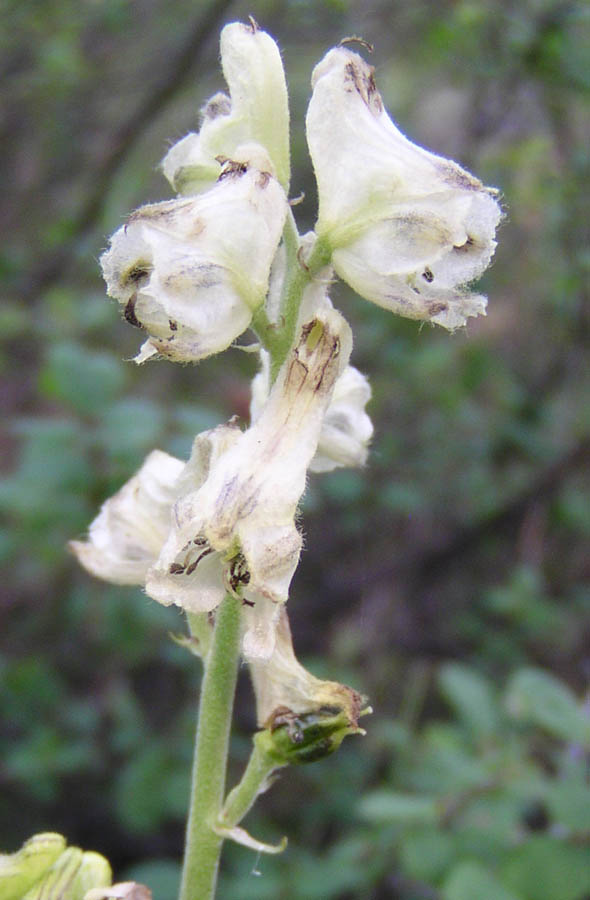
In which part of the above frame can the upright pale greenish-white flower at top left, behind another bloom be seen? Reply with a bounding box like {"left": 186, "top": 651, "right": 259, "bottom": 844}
{"left": 162, "top": 22, "right": 289, "bottom": 195}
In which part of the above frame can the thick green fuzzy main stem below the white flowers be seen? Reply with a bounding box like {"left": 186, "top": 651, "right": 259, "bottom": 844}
{"left": 179, "top": 595, "right": 240, "bottom": 900}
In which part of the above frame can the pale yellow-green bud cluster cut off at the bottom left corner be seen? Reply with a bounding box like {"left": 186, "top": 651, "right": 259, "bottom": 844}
{"left": 0, "top": 833, "right": 112, "bottom": 900}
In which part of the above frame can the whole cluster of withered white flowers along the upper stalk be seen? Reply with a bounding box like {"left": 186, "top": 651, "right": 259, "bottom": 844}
{"left": 71, "top": 21, "right": 501, "bottom": 728}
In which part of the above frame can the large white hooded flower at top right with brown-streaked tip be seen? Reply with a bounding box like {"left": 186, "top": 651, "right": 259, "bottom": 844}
{"left": 307, "top": 47, "right": 501, "bottom": 329}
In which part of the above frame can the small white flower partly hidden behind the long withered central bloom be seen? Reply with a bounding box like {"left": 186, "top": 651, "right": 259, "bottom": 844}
{"left": 250, "top": 350, "right": 373, "bottom": 472}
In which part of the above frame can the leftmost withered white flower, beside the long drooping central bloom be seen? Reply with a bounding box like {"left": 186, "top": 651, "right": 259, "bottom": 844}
{"left": 69, "top": 450, "right": 185, "bottom": 584}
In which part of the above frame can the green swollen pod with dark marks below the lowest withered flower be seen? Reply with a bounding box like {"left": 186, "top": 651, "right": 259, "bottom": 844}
{"left": 255, "top": 706, "right": 370, "bottom": 766}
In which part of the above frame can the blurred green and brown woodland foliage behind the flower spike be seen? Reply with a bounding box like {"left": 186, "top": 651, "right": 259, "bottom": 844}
{"left": 0, "top": 0, "right": 590, "bottom": 900}
